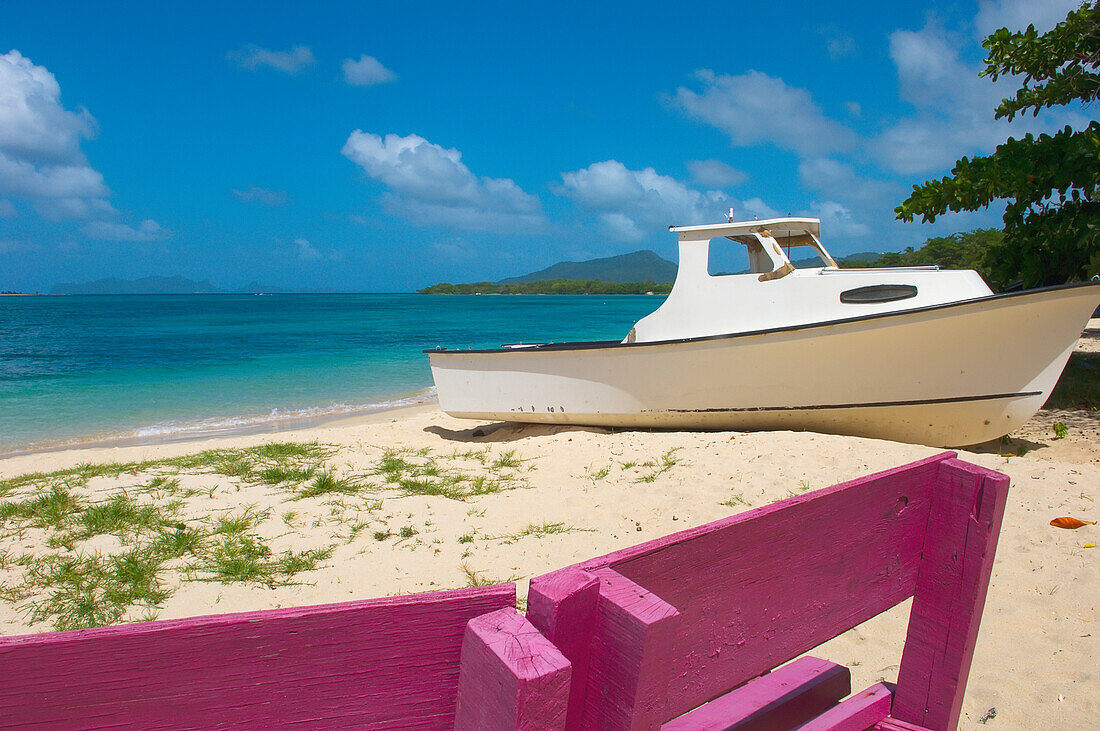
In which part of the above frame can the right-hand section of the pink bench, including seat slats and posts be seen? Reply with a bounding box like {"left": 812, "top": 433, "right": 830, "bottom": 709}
{"left": 457, "top": 453, "right": 1009, "bottom": 730}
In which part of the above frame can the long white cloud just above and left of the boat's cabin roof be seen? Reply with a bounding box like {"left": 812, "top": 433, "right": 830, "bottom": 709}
{"left": 558, "top": 159, "right": 771, "bottom": 242}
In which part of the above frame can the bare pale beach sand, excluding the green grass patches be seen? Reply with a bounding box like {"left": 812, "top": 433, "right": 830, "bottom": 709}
{"left": 0, "top": 321, "right": 1100, "bottom": 729}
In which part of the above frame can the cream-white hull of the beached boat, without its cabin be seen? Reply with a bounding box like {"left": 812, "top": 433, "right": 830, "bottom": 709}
{"left": 429, "top": 285, "right": 1100, "bottom": 446}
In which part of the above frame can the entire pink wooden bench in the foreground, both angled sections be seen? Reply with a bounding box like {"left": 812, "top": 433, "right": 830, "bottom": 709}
{"left": 0, "top": 453, "right": 1008, "bottom": 730}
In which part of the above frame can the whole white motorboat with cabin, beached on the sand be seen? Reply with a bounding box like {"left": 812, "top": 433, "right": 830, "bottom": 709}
{"left": 426, "top": 217, "right": 1100, "bottom": 446}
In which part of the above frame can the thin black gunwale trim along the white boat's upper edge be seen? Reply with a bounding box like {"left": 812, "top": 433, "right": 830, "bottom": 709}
{"left": 422, "top": 279, "right": 1100, "bottom": 355}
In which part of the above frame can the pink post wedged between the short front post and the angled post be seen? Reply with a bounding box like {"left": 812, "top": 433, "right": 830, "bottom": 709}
{"left": 527, "top": 568, "right": 600, "bottom": 729}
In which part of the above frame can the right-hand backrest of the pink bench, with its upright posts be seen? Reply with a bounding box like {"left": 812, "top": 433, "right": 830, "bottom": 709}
{"left": 528, "top": 453, "right": 1008, "bottom": 728}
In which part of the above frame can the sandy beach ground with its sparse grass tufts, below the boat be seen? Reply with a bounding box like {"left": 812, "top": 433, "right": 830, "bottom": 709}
{"left": 0, "top": 320, "right": 1100, "bottom": 729}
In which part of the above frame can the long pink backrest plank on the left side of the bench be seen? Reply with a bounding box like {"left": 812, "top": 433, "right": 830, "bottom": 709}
{"left": 0, "top": 584, "right": 515, "bottom": 729}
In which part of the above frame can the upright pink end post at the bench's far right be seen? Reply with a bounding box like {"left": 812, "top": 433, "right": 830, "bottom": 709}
{"left": 891, "top": 459, "right": 1009, "bottom": 729}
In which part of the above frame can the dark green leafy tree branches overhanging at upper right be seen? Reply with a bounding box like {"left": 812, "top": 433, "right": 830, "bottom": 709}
{"left": 895, "top": 2, "right": 1100, "bottom": 286}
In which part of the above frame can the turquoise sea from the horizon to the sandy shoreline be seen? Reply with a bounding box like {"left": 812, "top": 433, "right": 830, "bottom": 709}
{"left": 0, "top": 295, "right": 663, "bottom": 454}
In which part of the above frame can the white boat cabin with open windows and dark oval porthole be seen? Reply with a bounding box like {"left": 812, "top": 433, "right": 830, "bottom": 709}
{"left": 624, "top": 217, "right": 992, "bottom": 343}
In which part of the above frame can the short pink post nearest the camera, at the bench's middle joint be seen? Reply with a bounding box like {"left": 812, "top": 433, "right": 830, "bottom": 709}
{"left": 454, "top": 607, "right": 570, "bottom": 731}
